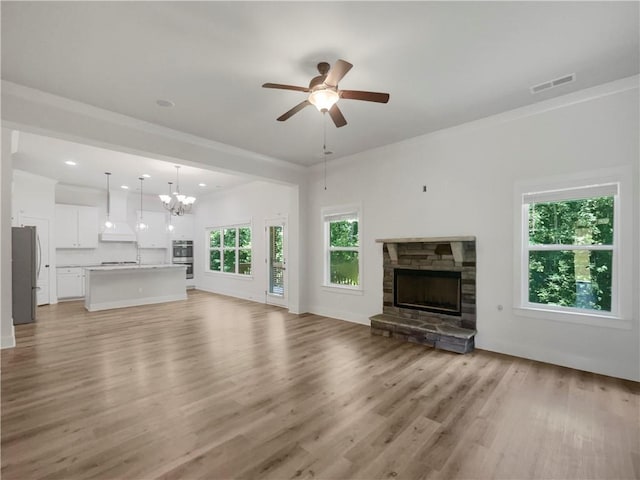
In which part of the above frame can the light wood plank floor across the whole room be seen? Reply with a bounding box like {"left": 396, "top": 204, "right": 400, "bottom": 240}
{"left": 2, "top": 292, "right": 640, "bottom": 480}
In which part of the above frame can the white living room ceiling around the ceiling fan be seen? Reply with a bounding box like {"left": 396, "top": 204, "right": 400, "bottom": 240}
{"left": 1, "top": 1, "right": 639, "bottom": 165}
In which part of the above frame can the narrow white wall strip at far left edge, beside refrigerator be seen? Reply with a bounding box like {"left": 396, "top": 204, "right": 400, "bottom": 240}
{"left": 0, "top": 128, "right": 16, "bottom": 348}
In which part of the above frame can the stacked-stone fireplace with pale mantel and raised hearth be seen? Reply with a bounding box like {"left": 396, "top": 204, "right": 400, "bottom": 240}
{"left": 371, "top": 237, "right": 476, "bottom": 353}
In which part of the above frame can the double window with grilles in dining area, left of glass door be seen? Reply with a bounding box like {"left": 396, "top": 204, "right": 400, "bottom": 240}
{"left": 207, "top": 225, "right": 251, "bottom": 275}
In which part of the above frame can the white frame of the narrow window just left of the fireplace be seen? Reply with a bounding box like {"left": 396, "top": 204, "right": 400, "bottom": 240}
{"left": 322, "top": 205, "right": 363, "bottom": 294}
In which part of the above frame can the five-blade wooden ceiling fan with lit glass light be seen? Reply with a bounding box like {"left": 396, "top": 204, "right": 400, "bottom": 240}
{"left": 262, "top": 60, "right": 389, "bottom": 127}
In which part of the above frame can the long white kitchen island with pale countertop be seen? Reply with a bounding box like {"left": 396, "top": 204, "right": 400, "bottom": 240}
{"left": 84, "top": 264, "right": 187, "bottom": 312}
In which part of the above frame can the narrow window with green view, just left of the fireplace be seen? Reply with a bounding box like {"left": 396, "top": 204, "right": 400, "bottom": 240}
{"left": 323, "top": 210, "right": 362, "bottom": 288}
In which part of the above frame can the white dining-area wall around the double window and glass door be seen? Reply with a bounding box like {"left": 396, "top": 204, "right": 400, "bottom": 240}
{"left": 193, "top": 182, "right": 299, "bottom": 312}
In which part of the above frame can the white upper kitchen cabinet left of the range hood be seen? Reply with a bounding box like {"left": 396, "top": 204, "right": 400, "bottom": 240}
{"left": 55, "top": 204, "right": 98, "bottom": 248}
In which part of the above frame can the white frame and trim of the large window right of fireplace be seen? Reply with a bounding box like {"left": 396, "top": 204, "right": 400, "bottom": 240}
{"left": 513, "top": 167, "right": 635, "bottom": 330}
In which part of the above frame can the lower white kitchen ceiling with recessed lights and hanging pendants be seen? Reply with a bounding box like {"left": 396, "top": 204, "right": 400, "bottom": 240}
{"left": 13, "top": 132, "right": 250, "bottom": 198}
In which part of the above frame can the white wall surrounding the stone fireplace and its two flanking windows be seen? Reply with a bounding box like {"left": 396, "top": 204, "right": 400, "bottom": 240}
{"left": 306, "top": 78, "right": 640, "bottom": 380}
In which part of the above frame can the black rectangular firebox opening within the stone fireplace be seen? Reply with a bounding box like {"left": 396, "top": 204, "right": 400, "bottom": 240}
{"left": 393, "top": 268, "right": 462, "bottom": 316}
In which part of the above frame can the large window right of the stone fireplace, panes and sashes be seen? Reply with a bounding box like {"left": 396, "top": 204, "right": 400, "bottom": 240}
{"left": 522, "top": 183, "right": 619, "bottom": 315}
